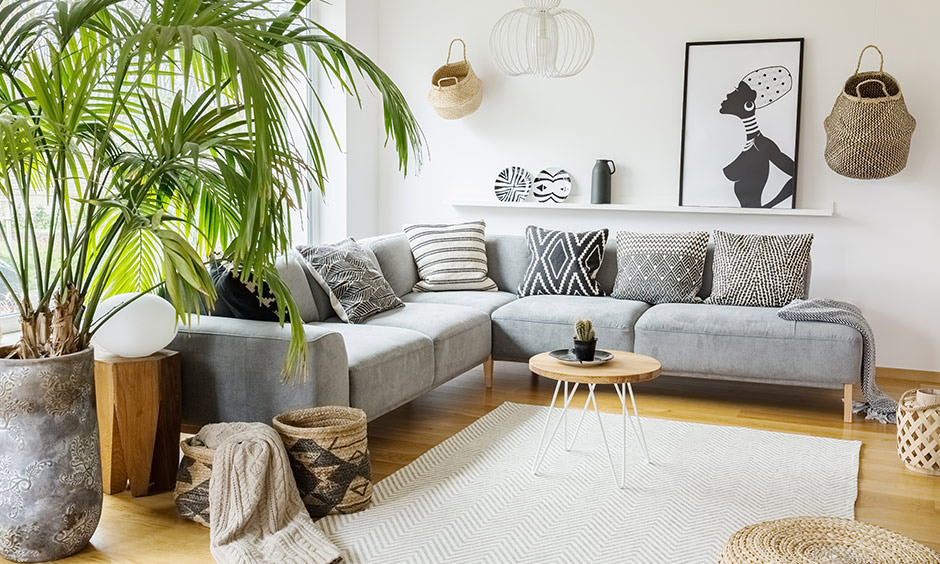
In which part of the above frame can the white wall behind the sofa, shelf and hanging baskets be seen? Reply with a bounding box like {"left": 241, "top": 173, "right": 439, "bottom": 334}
{"left": 340, "top": 0, "right": 940, "bottom": 370}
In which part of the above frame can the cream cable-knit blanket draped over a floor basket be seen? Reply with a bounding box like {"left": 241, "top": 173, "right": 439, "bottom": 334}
{"left": 196, "top": 423, "right": 343, "bottom": 564}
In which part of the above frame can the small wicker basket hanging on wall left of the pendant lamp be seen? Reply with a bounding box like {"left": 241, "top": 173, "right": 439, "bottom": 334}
{"left": 428, "top": 39, "right": 483, "bottom": 119}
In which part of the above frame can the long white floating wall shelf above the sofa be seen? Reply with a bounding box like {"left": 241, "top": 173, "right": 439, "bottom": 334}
{"left": 453, "top": 202, "right": 835, "bottom": 217}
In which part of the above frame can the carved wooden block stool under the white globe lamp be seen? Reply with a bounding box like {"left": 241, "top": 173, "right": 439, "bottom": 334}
{"left": 95, "top": 349, "right": 182, "bottom": 497}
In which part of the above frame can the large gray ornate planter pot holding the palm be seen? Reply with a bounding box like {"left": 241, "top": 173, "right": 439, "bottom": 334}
{"left": 0, "top": 348, "right": 102, "bottom": 562}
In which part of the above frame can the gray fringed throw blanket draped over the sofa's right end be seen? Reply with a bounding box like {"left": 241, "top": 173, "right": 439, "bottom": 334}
{"left": 777, "top": 298, "right": 898, "bottom": 423}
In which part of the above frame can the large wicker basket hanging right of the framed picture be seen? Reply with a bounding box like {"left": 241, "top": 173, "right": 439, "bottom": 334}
{"left": 824, "top": 45, "right": 917, "bottom": 180}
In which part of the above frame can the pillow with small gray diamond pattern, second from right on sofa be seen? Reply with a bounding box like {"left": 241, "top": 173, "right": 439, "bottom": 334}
{"left": 611, "top": 231, "right": 708, "bottom": 304}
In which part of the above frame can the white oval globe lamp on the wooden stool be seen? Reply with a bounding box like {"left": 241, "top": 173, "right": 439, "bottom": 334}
{"left": 91, "top": 294, "right": 177, "bottom": 358}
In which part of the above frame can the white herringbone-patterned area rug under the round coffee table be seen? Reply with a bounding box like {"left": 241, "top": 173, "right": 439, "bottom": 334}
{"left": 320, "top": 403, "right": 861, "bottom": 564}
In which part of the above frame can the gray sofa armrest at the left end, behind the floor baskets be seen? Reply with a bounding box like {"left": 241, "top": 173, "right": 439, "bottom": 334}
{"left": 169, "top": 316, "right": 349, "bottom": 425}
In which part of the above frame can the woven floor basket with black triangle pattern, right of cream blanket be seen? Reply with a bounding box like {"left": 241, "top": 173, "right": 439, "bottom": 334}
{"left": 274, "top": 407, "right": 372, "bottom": 518}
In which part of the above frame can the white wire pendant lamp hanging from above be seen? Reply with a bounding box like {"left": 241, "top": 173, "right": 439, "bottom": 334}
{"left": 490, "top": 0, "right": 594, "bottom": 78}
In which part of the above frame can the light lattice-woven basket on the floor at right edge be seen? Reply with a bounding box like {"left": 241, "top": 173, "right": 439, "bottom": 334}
{"left": 897, "top": 390, "right": 940, "bottom": 476}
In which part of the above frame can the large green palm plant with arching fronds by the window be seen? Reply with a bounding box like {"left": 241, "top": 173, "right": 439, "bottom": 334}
{"left": 0, "top": 0, "right": 423, "bottom": 373}
